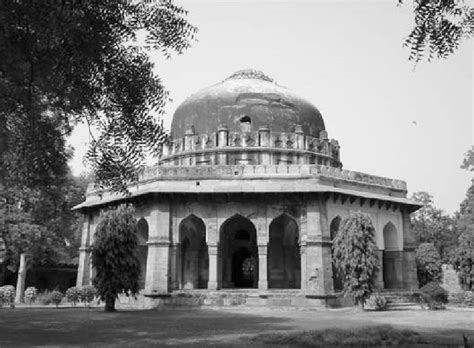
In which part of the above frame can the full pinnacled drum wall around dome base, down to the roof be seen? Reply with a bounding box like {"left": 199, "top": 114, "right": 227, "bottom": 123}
{"left": 159, "top": 125, "right": 342, "bottom": 168}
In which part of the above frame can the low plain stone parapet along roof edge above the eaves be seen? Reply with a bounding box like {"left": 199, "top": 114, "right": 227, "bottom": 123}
{"left": 134, "top": 164, "right": 407, "bottom": 190}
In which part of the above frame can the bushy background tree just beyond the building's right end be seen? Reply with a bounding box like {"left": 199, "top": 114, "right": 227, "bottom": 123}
{"left": 411, "top": 192, "right": 458, "bottom": 263}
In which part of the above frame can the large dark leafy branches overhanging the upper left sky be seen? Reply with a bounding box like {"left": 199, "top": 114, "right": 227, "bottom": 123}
{"left": 0, "top": 0, "right": 197, "bottom": 192}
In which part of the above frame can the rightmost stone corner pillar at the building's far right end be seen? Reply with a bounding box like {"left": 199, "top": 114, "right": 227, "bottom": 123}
{"left": 402, "top": 209, "right": 418, "bottom": 290}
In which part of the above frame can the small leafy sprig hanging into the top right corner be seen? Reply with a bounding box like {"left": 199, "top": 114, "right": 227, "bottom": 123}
{"left": 398, "top": 0, "right": 474, "bottom": 63}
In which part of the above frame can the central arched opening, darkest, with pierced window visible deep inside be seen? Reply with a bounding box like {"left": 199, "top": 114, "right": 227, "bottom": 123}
{"left": 219, "top": 215, "right": 258, "bottom": 288}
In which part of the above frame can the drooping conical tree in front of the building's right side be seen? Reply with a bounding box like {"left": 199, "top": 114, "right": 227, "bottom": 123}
{"left": 333, "top": 212, "right": 379, "bottom": 308}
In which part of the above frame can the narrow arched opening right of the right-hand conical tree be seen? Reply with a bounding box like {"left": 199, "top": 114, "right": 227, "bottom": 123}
{"left": 382, "top": 222, "right": 398, "bottom": 289}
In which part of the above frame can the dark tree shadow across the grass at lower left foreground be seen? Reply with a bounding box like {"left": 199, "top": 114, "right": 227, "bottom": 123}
{"left": 0, "top": 308, "right": 289, "bottom": 346}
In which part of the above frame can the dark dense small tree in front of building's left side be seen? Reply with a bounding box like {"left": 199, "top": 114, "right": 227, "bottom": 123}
{"left": 92, "top": 205, "right": 140, "bottom": 311}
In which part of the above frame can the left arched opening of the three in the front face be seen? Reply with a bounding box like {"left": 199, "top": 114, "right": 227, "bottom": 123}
{"left": 179, "top": 215, "right": 209, "bottom": 289}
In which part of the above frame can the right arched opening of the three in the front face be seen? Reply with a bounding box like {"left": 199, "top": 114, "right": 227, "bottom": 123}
{"left": 267, "top": 214, "right": 301, "bottom": 289}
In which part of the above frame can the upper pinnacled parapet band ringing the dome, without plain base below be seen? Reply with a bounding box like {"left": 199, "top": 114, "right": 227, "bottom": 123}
{"left": 159, "top": 125, "right": 342, "bottom": 167}
